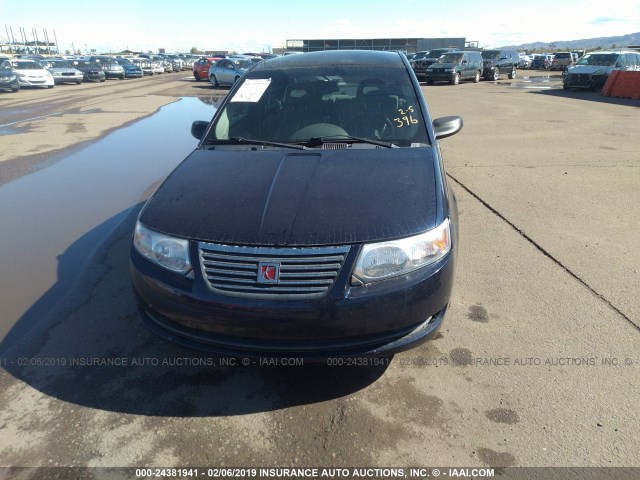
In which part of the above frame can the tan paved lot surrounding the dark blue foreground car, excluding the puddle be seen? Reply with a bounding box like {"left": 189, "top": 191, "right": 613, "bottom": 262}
{"left": 0, "top": 71, "right": 640, "bottom": 474}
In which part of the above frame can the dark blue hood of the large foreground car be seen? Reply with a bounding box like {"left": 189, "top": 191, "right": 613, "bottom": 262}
{"left": 140, "top": 147, "right": 442, "bottom": 246}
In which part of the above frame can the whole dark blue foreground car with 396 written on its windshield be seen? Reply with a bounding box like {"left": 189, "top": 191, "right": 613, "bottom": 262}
{"left": 130, "top": 50, "right": 462, "bottom": 362}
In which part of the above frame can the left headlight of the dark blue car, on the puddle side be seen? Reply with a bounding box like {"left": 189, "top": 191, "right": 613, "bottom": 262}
{"left": 133, "top": 222, "right": 191, "bottom": 274}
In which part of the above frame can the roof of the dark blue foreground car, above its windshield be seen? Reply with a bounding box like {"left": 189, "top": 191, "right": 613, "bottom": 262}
{"left": 255, "top": 50, "right": 404, "bottom": 69}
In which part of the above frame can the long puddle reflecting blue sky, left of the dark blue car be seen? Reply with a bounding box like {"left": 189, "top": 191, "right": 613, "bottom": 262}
{"left": 0, "top": 98, "right": 215, "bottom": 341}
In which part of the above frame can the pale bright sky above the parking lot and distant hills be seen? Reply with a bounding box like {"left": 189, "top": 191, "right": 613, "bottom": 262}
{"left": 0, "top": 0, "right": 640, "bottom": 52}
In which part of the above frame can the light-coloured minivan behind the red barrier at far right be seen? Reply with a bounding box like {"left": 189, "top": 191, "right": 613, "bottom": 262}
{"left": 562, "top": 50, "right": 640, "bottom": 90}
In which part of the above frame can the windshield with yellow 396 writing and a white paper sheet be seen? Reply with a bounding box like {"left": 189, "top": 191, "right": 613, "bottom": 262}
{"left": 205, "top": 64, "right": 429, "bottom": 146}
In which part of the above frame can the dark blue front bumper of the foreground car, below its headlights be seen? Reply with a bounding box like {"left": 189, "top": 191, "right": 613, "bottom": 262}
{"left": 131, "top": 247, "right": 455, "bottom": 361}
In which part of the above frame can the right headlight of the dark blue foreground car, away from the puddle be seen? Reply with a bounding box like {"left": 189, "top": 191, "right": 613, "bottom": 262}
{"left": 353, "top": 219, "right": 451, "bottom": 283}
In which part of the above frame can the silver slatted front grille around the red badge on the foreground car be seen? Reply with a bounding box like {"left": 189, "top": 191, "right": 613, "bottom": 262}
{"left": 198, "top": 246, "right": 350, "bottom": 299}
